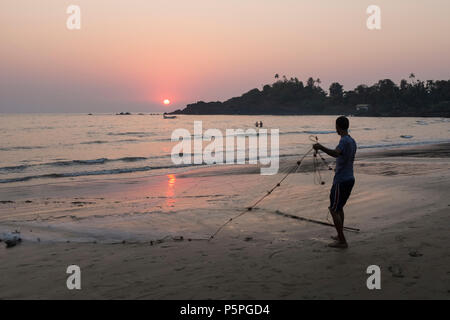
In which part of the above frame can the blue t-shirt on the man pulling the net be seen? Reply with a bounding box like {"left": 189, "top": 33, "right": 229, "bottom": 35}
{"left": 333, "top": 135, "right": 356, "bottom": 183}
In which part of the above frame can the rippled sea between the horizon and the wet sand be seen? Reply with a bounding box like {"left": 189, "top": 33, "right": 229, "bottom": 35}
{"left": 0, "top": 114, "right": 450, "bottom": 186}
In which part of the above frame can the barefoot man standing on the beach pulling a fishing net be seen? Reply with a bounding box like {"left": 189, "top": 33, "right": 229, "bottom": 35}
{"left": 313, "top": 116, "right": 356, "bottom": 249}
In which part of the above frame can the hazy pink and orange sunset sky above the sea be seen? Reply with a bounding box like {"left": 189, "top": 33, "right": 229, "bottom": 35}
{"left": 0, "top": 0, "right": 450, "bottom": 112}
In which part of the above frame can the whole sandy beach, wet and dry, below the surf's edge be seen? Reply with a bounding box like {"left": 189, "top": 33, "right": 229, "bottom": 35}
{"left": 0, "top": 144, "right": 450, "bottom": 299}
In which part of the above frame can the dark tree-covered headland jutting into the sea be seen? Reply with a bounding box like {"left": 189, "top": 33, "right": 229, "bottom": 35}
{"left": 175, "top": 73, "right": 450, "bottom": 117}
